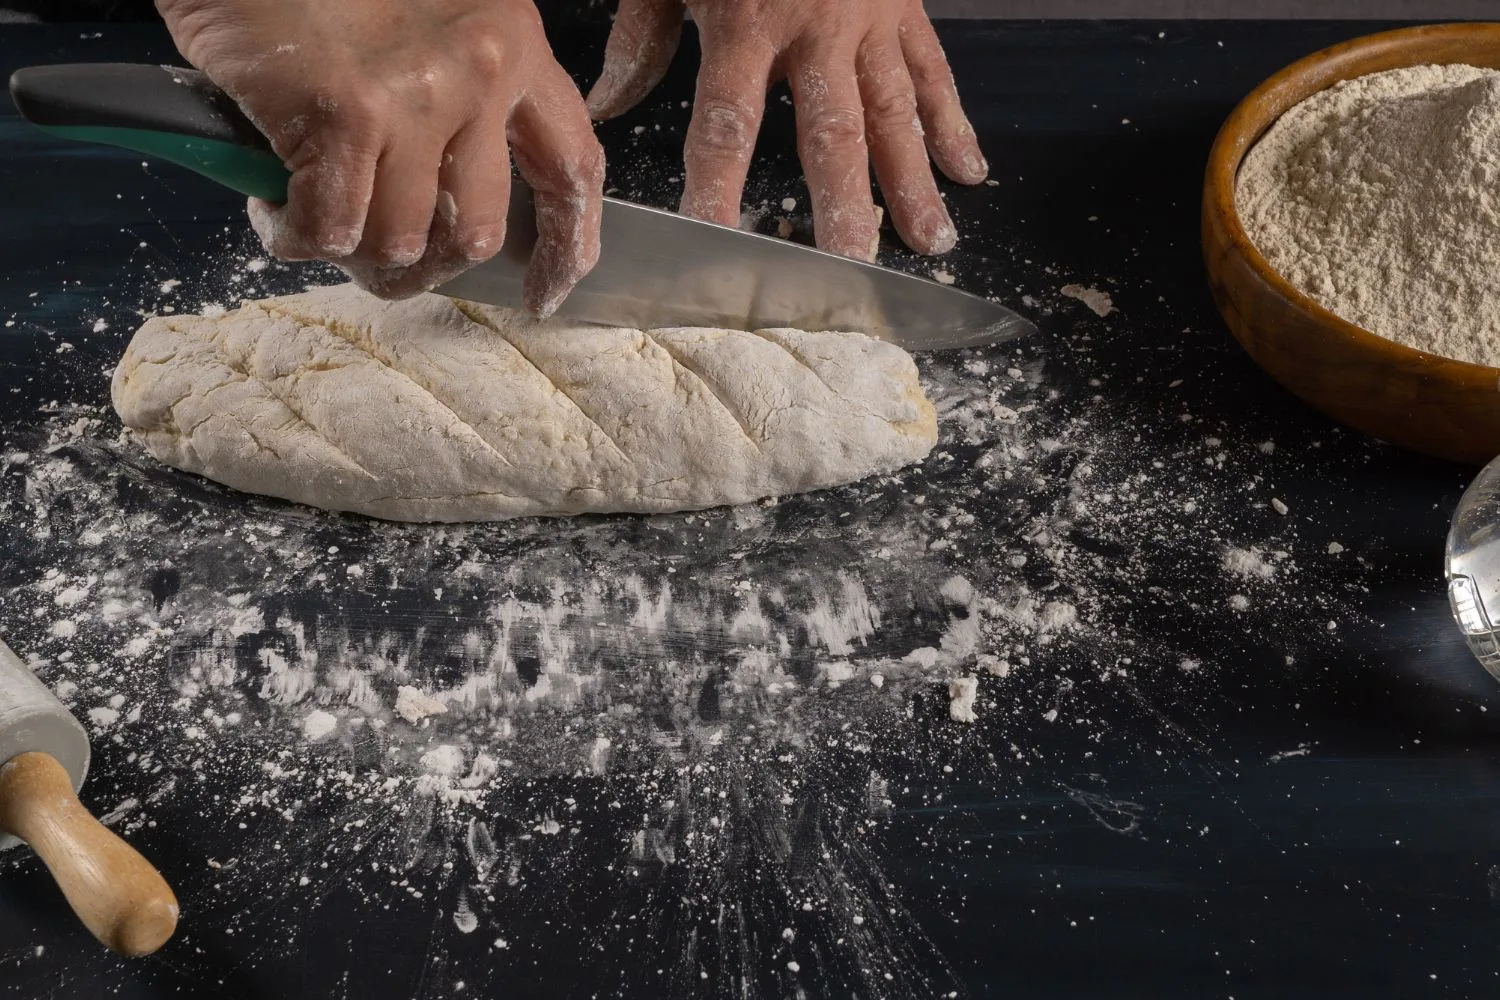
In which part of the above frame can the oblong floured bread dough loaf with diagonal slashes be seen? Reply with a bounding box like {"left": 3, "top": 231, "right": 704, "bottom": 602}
{"left": 113, "top": 285, "right": 938, "bottom": 522}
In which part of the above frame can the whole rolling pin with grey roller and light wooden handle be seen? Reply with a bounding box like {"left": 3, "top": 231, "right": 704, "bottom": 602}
{"left": 0, "top": 642, "right": 177, "bottom": 957}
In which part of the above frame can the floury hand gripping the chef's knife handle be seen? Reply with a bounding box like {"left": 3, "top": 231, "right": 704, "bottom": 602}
{"left": 158, "top": 0, "right": 605, "bottom": 315}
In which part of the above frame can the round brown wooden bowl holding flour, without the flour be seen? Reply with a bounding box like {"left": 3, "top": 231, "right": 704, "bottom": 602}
{"left": 1203, "top": 24, "right": 1500, "bottom": 465}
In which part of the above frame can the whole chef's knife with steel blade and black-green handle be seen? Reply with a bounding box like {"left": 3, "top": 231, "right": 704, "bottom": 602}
{"left": 11, "top": 63, "right": 1035, "bottom": 351}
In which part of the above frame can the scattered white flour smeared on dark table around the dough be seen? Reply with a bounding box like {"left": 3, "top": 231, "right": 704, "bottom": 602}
{"left": 0, "top": 217, "right": 1361, "bottom": 997}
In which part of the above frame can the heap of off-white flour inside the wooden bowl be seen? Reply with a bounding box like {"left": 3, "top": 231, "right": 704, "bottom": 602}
{"left": 1236, "top": 66, "right": 1500, "bottom": 366}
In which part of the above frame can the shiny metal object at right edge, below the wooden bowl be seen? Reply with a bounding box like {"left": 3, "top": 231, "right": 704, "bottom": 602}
{"left": 1445, "top": 459, "right": 1500, "bottom": 681}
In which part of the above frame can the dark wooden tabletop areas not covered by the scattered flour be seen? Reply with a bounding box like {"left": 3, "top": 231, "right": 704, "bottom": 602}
{"left": 0, "top": 21, "right": 1500, "bottom": 1000}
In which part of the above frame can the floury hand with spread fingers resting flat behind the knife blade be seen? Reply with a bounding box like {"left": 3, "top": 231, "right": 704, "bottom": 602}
{"left": 588, "top": 0, "right": 989, "bottom": 258}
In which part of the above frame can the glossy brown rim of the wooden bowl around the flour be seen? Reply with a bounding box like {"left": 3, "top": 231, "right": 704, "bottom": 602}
{"left": 1208, "top": 21, "right": 1500, "bottom": 388}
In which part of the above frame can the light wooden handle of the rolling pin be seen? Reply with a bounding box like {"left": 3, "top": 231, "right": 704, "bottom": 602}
{"left": 0, "top": 753, "right": 177, "bottom": 957}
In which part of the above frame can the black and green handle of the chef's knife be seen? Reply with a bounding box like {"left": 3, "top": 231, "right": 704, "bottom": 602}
{"left": 11, "top": 63, "right": 291, "bottom": 204}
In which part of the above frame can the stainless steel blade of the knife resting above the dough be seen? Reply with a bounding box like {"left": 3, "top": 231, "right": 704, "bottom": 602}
{"left": 437, "top": 178, "right": 1037, "bottom": 351}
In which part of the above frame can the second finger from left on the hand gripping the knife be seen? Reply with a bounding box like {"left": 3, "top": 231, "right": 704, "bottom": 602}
{"left": 356, "top": 135, "right": 443, "bottom": 267}
